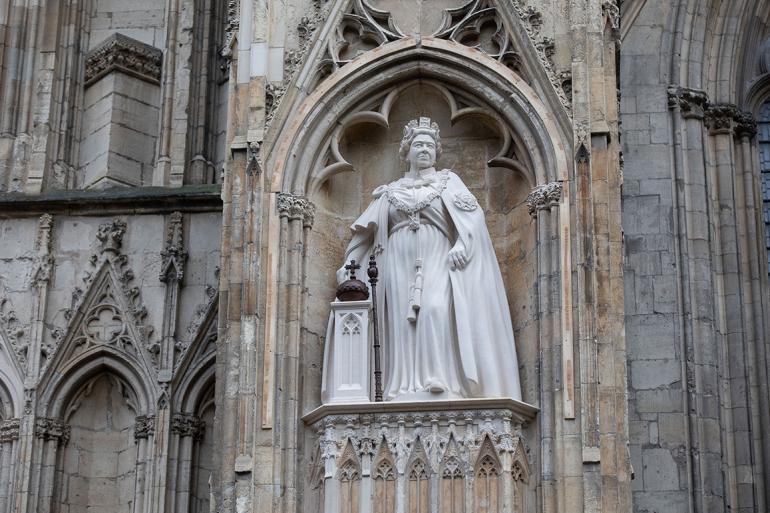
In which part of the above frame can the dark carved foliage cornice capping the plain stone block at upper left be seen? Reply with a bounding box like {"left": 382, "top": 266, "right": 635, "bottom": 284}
{"left": 85, "top": 33, "right": 163, "bottom": 87}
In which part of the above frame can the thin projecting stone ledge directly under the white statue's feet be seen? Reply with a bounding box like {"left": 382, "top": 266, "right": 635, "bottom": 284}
{"left": 302, "top": 397, "right": 540, "bottom": 425}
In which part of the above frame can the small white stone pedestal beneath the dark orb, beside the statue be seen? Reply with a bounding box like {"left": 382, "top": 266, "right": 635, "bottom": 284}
{"left": 322, "top": 300, "right": 372, "bottom": 404}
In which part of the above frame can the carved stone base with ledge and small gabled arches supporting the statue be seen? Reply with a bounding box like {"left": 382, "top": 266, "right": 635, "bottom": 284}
{"left": 304, "top": 399, "right": 537, "bottom": 513}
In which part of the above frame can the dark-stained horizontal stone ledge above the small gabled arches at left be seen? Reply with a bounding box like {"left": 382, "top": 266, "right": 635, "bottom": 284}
{"left": 0, "top": 184, "right": 222, "bottom": 217}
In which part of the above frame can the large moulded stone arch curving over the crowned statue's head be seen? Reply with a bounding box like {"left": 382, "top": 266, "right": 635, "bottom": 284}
{"left": 267, "top": 37, "right": 571, "bottom": 194}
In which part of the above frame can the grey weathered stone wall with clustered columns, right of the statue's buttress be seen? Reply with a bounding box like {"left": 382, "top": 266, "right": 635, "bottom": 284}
{"left": 620, "top": 2, "right": 770, "bottom": 512}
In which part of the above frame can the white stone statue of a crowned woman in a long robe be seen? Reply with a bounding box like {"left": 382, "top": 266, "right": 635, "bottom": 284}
{"left": 323, "top": 118, "right": 521, "bottom": 401}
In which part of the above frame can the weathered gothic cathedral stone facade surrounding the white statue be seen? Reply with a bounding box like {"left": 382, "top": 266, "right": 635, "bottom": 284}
{"left": 0, "top": 0, "right": 770, "bottom": 513}
